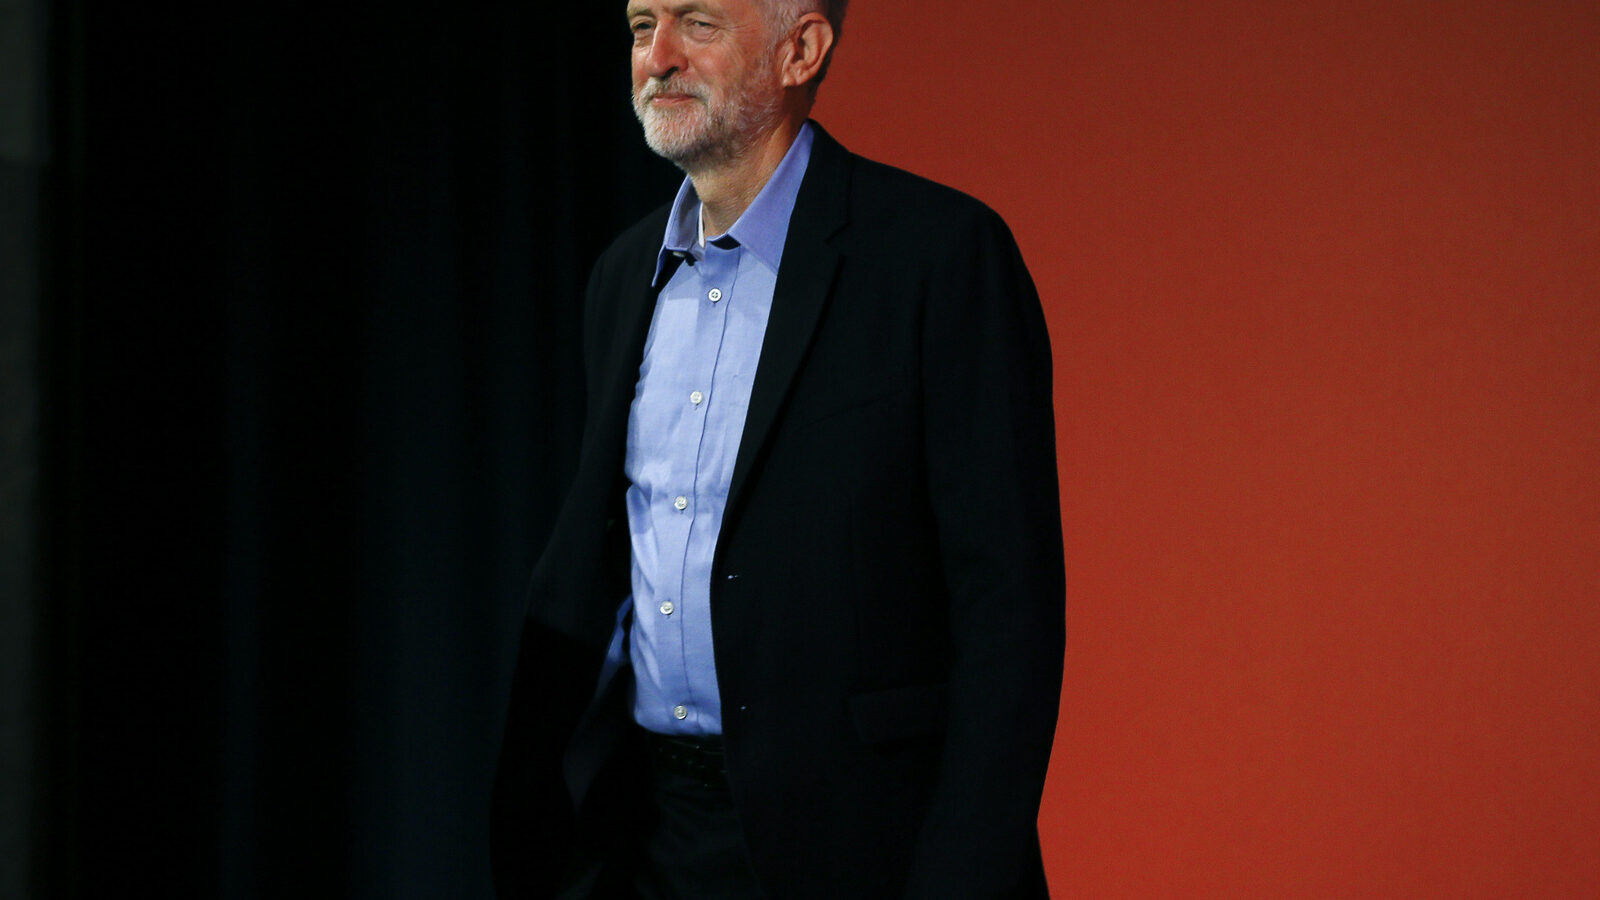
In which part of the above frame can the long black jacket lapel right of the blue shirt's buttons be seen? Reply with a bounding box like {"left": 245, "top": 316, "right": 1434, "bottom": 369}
{"left": 723, "top": 122, "right": 850, "bottom": 528}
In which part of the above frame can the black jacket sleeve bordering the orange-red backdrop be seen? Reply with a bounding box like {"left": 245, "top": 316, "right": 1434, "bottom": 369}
{"left": 907, "top": 208, "right": 1066, "bottom": 900}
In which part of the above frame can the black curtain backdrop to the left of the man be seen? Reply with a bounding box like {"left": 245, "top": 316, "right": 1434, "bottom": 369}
{"left": 34, "top": 0, "right": 678, "bottom": 898}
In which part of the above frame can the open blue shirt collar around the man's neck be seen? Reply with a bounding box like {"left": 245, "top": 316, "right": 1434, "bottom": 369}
{"left": 651, "top": 122, "right": 814, "bottom": 288}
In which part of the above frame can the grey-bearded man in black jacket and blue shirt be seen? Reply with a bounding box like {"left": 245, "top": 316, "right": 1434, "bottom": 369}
{"left": 494, "top": 0, "right": 1064, "bottom": 900}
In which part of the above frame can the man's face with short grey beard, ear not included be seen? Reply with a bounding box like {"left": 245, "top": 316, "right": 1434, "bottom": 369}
{"left": 627, "top": 0, "right": 784, "bottom": 168}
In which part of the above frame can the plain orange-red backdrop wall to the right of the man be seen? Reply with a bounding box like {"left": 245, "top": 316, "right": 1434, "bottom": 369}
{"left": 818, "top": 0, "right": 1600, "bottom": 898}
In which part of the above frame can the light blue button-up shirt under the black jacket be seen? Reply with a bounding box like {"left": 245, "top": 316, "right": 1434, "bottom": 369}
{"left": 613, "top": 123, "right": 813, "bottom": 735}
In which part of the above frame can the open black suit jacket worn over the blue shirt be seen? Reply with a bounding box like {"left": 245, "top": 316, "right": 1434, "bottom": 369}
{"left": 493, "top": 128, "right": 1064, "bottom": 900}
